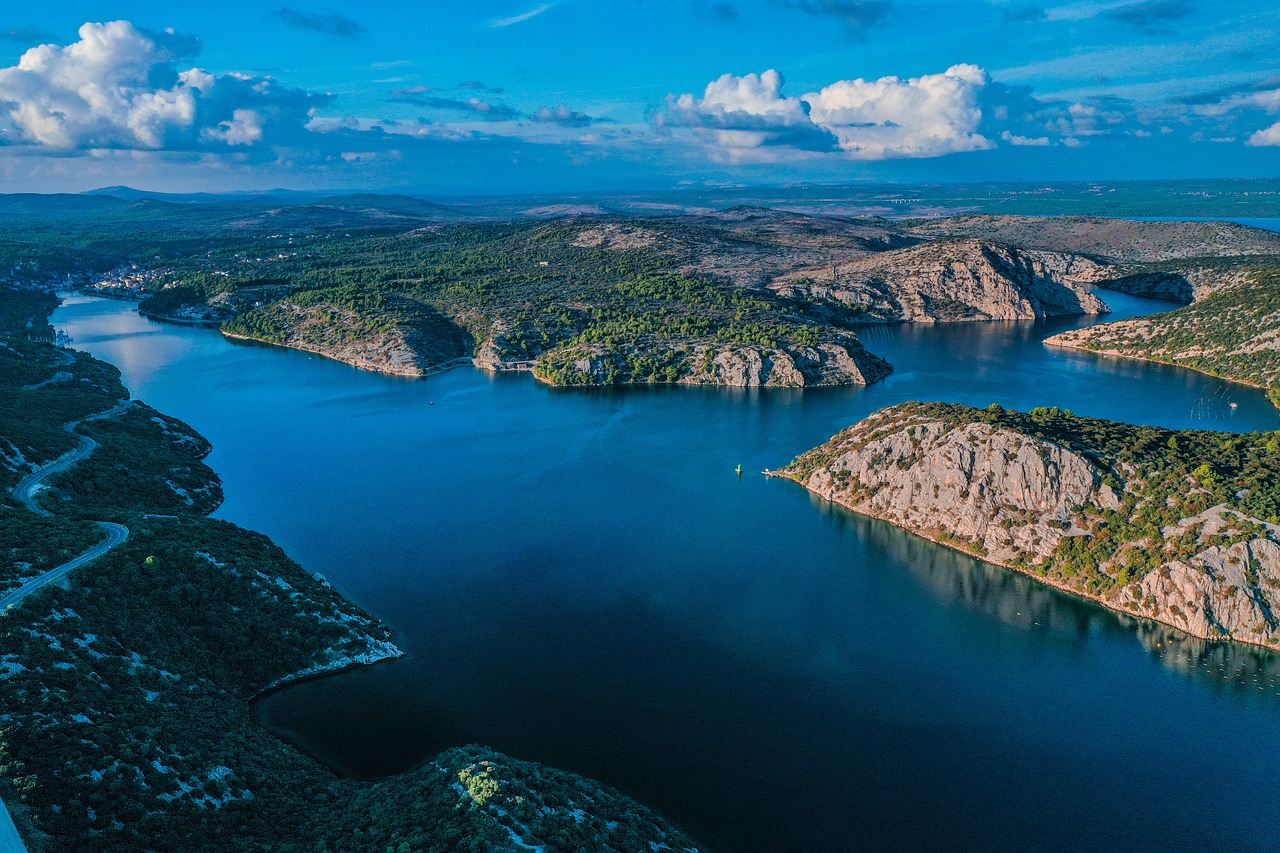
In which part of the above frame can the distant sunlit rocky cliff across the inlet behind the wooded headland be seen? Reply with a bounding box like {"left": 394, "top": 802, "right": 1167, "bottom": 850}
{"left": 772, "top": 240, "right": 1117, "bottom": 323}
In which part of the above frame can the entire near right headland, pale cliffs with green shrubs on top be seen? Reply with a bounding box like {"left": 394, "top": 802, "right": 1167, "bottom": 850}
{"left": 773, "top": 403, "right": 1280, "bottom": 647}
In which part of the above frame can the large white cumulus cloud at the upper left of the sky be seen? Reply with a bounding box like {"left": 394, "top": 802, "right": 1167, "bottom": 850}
{"left": 0, "top": 20, "right": 326, "bottom": 150}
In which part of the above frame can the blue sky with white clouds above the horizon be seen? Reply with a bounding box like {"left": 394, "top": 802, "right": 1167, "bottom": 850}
{"left": 0, "top": 0, "right": 1280, "bottom": 195}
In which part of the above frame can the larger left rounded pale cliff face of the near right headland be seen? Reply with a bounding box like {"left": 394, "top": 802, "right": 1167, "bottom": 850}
{"left": 801, "top": 412, "right": 1106, "bottom": 562}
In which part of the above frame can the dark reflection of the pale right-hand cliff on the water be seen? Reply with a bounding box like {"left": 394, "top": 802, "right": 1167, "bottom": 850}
{"left": 810, "top": 494, "right": 1280, "bottom": 699}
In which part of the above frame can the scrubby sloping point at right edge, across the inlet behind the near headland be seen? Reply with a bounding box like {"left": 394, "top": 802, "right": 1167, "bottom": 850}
{"left": 1044, "top": 269, "right": 1280, "bottom": 405}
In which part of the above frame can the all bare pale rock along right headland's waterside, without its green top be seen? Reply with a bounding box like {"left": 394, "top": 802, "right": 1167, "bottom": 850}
{"left": 773, "top": 403, "right": 1280, "bottom": 648}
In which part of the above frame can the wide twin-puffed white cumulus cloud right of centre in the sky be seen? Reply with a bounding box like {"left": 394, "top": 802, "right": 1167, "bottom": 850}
{"left": 658, "top": 65, "right": 995, "bottom": 160}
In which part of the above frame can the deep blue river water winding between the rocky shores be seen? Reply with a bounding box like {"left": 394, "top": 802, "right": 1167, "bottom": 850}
{"left": 54, "top": 292, "right": 1280, "bottom": 853}
